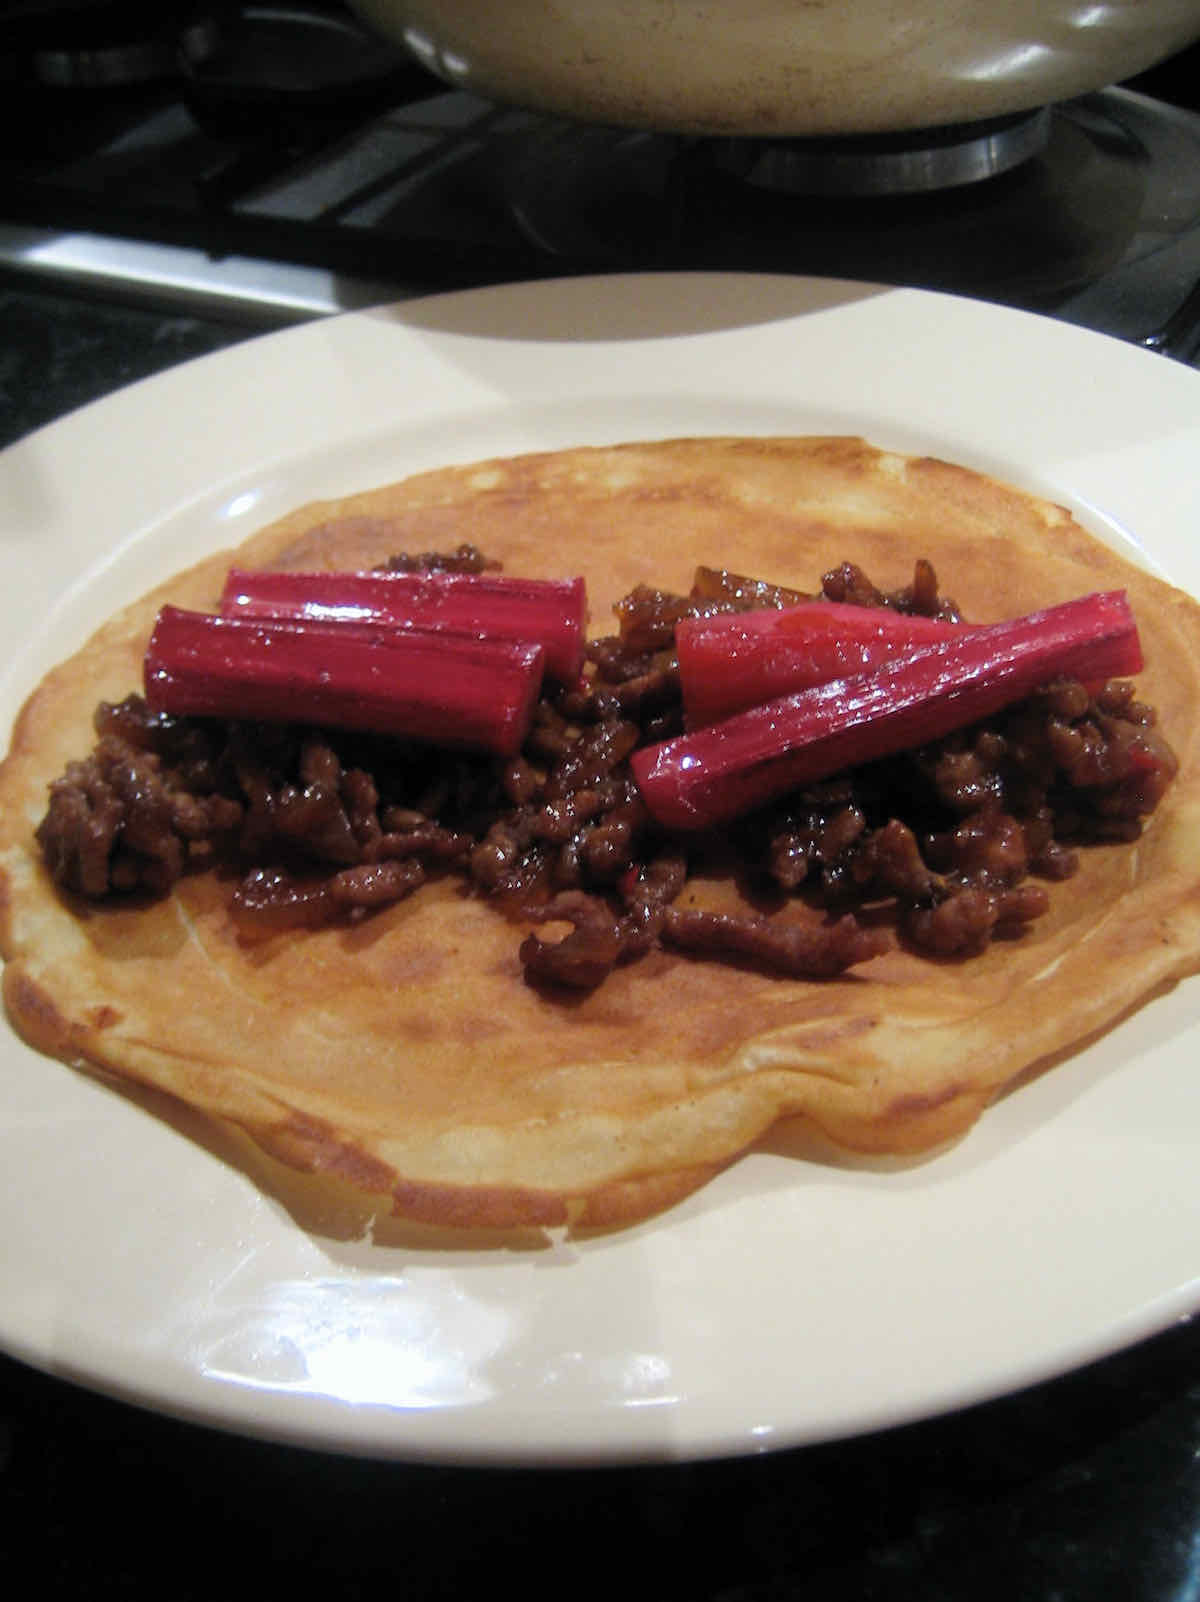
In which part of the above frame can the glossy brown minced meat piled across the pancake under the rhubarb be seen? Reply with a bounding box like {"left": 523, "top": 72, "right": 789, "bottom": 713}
{"left": 37, "top": 560, "right": 1176, "bottom": 990}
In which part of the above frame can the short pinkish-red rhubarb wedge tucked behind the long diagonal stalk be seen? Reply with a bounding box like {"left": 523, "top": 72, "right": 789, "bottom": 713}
{"left": 674, "top": 601, "right": 968, "bottom": 729}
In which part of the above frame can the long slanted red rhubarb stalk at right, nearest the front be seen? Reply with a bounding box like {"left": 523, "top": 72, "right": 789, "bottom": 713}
{"left": 631, "top": 591, "right": 1142, "bottom": 830}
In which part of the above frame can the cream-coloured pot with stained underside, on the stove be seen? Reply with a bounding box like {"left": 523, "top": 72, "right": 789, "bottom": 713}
{"left": 351, "top": 0, "right": 1200, "bottom": 139}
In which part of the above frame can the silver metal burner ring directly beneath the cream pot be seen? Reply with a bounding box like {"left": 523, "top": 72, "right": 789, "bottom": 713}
{"left": 716, "top": 109, "right": 1051, "bottom": 195}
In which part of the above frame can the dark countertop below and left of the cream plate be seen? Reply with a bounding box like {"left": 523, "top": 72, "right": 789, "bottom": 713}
{"left": 0, "top": 284, "right": 1200, "bottom": 1602}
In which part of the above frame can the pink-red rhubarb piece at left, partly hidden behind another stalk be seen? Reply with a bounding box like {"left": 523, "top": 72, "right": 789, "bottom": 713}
{"left": 221, "top": 567, "right": 588, "bottom": 684}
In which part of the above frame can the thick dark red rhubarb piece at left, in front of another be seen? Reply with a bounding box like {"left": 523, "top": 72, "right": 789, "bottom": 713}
{"left": 144, "top": 606, "right": 545, "bottom": 756}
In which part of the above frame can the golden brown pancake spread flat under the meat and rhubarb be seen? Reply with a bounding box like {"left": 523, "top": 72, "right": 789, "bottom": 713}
{"left": 0, "top": 439, "right": 1200, "bottom": 1227}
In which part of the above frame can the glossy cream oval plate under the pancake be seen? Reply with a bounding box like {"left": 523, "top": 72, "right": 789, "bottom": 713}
{"left": 0, "top": 276, "right": 1200, "bottom": 1463}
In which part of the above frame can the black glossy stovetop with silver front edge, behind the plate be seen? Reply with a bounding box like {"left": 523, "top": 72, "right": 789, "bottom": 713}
{"left": 0, "top": 6, "right": 1200, "bottom": 350}
